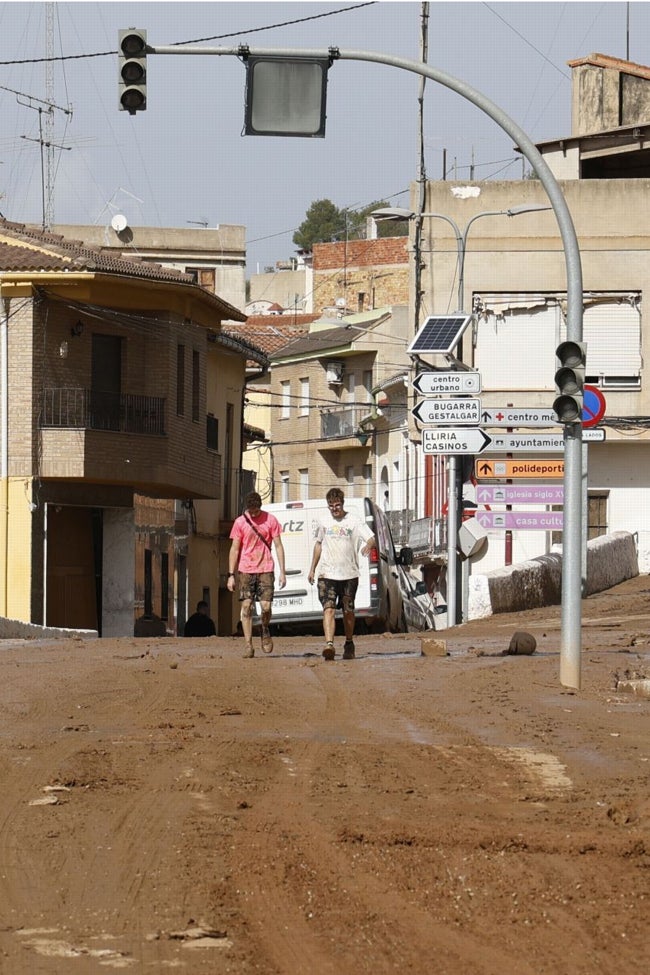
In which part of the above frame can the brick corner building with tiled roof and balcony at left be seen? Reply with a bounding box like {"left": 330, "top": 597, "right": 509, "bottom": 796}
{"left": 0, "top": 221, "right": 258, "bottom": 636}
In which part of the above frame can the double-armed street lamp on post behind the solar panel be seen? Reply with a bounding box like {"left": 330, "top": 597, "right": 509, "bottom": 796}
{"left": 371, "top": 203, "right": 552, "bottom": 626}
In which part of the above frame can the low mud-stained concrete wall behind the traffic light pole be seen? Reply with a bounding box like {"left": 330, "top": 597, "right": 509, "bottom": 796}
{"left": 468, "top": 532, "right": 639, "bottom": 619}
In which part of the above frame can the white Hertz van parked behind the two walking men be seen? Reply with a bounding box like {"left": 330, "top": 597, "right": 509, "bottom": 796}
{"left": 264, "top": 498, "right": 412, "bottom": 633}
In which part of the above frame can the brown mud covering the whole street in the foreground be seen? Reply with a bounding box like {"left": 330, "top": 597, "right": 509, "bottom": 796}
{"left": 0, "top": 577, "right": 650, "bottom": 975}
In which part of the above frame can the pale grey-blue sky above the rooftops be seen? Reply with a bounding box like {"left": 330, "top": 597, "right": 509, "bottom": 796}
{"left": 0, "top": 0, "right": 650, "bottom": 274}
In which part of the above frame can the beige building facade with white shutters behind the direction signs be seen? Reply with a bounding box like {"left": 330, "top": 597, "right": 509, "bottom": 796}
{"left": 411, "top": 49, "right": 650, "bottom": 584}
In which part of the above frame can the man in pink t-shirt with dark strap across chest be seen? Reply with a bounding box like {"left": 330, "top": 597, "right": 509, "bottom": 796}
{"left": 227, "top": 491, "right": 287, "bottom": 657}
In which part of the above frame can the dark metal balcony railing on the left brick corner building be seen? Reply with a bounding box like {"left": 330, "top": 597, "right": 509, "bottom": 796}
{"left": 40, "top": 387, "right": 165, "bottom": 436}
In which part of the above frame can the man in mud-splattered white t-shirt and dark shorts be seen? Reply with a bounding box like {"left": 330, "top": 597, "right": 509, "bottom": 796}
{"left": 308, "top": 488, "right": 377, "bottom": 660}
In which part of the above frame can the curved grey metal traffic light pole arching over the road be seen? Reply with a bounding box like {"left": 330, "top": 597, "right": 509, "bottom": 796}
{"left": 139, "top": 36, "right": 583, "bottom": 689}
